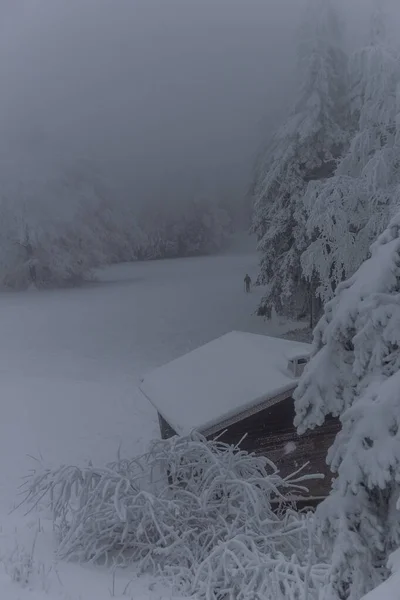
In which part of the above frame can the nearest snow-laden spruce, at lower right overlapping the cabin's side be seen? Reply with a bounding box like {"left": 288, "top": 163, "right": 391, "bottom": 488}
{"left": 295, "top": 213, "right": 400, "bottom": 600}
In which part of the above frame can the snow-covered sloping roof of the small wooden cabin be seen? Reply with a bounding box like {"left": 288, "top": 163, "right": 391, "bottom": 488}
{"left": 140, "top": 331, "right": 311, "bottom": 435}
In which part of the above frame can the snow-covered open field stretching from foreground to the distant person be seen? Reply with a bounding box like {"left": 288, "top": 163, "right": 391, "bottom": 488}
{"left": 0, "top": 239, "right": 302, "bottom": 600}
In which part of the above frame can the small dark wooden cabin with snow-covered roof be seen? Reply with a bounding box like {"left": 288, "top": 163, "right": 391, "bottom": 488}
{"left": 140, "top": 331, "right": 338, "bottom": 500}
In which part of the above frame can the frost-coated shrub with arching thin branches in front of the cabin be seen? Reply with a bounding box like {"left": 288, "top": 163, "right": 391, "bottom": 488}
{"left": 21, "top": 434, "right": 326, "bottom": 600}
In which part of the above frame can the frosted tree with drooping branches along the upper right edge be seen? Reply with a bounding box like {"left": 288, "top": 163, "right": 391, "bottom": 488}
{"left": 301, "top": 0, "right": 400, "bottom": 302}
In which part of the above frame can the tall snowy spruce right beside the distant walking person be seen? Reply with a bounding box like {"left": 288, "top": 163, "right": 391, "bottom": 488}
{"left": 253, "top": 0, "right": 347, "bottom": 324}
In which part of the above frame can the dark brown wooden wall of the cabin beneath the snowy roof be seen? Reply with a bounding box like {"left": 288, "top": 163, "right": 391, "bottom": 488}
{"left": 213, "top": 398, "right": 340, "bottom": 498}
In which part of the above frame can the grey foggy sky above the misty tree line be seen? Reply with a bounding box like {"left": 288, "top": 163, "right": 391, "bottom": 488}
{"left": 0, "top": 0, "right": 396, "bottom": 210}
